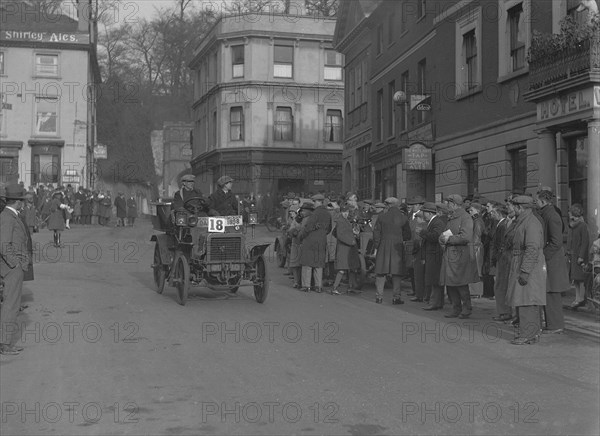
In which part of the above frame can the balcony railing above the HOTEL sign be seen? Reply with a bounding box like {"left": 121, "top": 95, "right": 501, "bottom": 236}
{"left": 529, "top": 36, "right": 600, "bottom": 91}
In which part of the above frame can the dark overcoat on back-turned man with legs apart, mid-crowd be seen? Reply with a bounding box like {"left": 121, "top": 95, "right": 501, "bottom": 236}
{"left": 373, "top": 207, "right": 411, "bottom": 275}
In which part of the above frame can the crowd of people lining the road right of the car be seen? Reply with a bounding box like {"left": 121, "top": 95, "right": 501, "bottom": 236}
{"left": 282, "top": 187, "right": 600, "bottom": 345}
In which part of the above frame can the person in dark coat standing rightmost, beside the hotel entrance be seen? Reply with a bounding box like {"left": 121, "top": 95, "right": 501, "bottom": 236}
{"left": 567, "top": 204, "right": 590, "bottom": 309}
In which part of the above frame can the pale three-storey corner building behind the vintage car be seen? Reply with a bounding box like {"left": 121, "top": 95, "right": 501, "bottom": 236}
{"left": 190, "top": 14, "right": 344, "bottom": 196}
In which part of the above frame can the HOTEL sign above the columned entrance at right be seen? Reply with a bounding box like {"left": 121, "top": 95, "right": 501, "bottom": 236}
{"left": 537, "top": 86, "right": 600, "bottom": 122}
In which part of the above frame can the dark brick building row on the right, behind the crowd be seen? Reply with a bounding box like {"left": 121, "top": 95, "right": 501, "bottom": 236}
{"left": 335, "top": 0, "right": 600, "bottom": 232}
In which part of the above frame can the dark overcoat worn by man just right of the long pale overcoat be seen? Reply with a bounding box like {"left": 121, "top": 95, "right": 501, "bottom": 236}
{"left": 539, "top": 204, "right": 571, "bottom": 292}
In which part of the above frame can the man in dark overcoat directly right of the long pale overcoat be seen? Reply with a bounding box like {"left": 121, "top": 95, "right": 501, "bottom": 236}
{"left": 536, "top": 189, "right": 571, "bottom": 333}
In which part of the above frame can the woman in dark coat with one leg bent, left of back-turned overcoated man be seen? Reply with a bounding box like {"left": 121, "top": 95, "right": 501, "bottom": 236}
{"left": 331, "top": 205, "right": 360, "bottom": 295}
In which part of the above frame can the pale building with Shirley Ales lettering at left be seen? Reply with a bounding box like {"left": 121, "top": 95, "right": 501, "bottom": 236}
{"left": 0, "top": 2, "right": 100, "bottom": 187}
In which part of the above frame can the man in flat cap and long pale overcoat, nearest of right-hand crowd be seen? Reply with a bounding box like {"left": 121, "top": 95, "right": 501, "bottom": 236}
{"left": 506, "top": 195, "right": 546, "bottom": 345}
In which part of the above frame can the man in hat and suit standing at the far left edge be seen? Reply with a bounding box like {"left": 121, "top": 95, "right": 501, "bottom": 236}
{"left": 0, "top": 184, "right": 31, "bottom": 355}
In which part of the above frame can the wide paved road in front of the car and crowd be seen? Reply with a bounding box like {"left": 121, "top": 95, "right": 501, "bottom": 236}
{"left": 0, "top": 222, "right": 600, "bottom": 435}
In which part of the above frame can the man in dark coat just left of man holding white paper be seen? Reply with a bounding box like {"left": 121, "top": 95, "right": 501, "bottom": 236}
{"left": 419, "top": 203, "right": 446, "bottom": 310}
